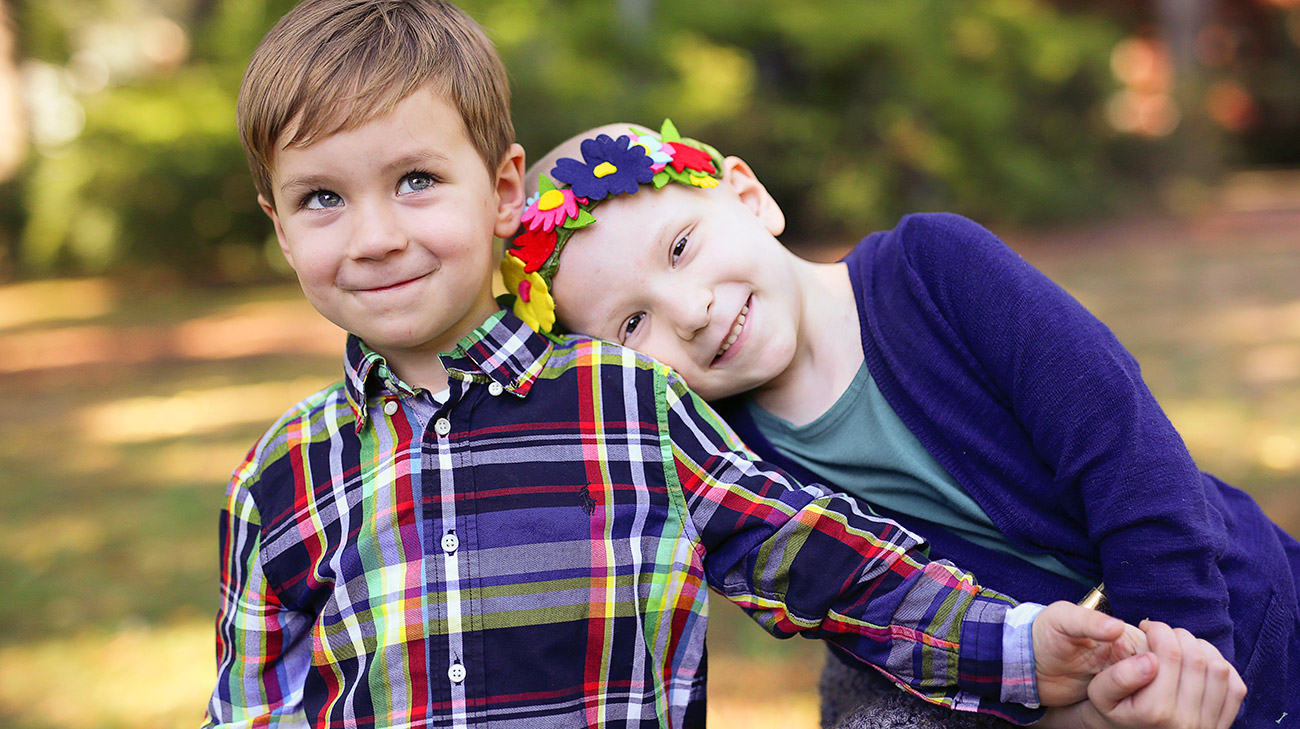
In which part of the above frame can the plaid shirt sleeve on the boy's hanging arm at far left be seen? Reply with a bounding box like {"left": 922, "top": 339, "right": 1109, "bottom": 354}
{"left": 203, "top": 480, "right": 311, "bottom": 728}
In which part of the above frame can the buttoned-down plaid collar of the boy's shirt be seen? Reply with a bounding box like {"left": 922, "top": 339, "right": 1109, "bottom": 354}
{"left": 343, "top": 309, "right": 551, "bottom": 429}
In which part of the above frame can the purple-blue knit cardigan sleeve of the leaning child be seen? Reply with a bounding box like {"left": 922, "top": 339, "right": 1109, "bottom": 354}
{"left": 896, "top": 214, "right": 1234, "bottom": 660}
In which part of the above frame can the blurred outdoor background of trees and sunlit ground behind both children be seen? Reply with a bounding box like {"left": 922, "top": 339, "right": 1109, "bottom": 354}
{"left": 0, "top": 0, "right": 1300, "bottom": 729}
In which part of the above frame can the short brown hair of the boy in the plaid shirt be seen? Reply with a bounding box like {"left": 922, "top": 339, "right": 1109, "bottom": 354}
{"left": 235, "top": 0, "right": 515, "bottom": 203}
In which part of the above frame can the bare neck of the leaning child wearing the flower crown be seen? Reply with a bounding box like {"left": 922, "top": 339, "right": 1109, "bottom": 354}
{"left": 753, "top": 259, "right": 862, "bottom": 425}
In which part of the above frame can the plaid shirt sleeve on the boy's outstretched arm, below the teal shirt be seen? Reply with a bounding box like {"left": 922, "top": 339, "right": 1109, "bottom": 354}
{"left": 663, "top": 373, "right": 1041, "bottom": 724}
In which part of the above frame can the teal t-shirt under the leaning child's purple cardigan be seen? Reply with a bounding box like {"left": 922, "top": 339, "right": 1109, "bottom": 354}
{"left": 748, "top": 364, "right": 1093, "bottom": 585}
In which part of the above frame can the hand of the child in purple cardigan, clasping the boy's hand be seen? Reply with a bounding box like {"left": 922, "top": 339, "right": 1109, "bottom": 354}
{"left": 1048, "top": 620, "right": 1245, "bottom": 729}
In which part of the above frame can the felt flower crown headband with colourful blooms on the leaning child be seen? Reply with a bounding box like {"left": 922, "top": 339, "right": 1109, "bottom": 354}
{"left": 501, "top": 120, "right": 723, "bottom": 333}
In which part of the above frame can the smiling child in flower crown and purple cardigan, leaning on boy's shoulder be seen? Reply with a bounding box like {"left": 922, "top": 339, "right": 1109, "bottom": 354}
{"left": 503, "top": 123, "right": 1274, "bottom": 726}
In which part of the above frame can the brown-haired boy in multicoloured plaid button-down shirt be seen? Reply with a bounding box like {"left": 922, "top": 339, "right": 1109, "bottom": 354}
{"left": 207, "top": 0, "right": 1190, "bottom": 729}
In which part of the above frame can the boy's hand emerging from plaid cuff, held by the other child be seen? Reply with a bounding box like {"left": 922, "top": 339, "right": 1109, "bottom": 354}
{"left": 1034, "top": 602, "right": 1147, "bottom": 706}
